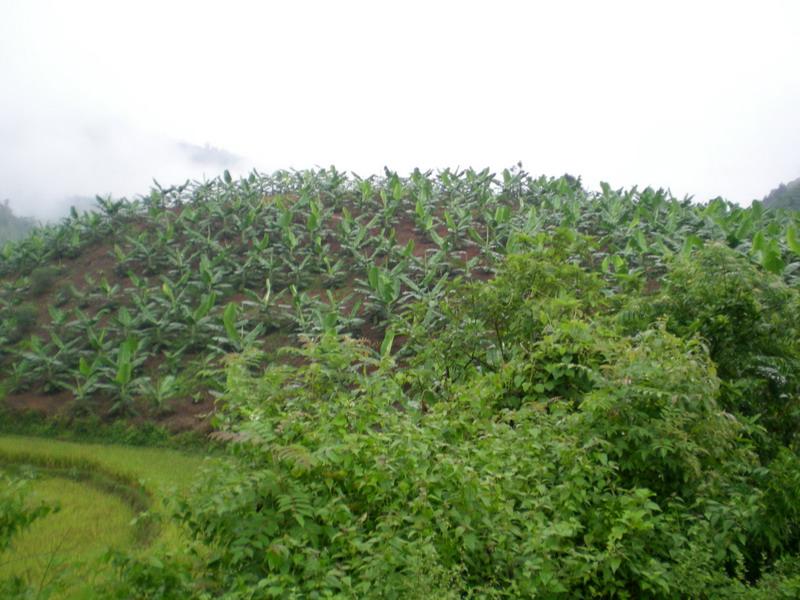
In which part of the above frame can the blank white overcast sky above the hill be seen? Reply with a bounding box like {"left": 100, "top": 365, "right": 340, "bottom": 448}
{"left": 0, "top": 0, "right": 800, "bottom": 217}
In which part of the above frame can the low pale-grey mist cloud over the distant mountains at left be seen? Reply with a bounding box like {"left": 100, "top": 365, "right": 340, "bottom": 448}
{"left": 0, "top": 104, "right": 248, "bottom": 220}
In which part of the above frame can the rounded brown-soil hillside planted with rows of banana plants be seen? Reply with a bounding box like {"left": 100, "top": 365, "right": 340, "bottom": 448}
{"left": 0, "top": 169, "right": 800, "bottom": 429}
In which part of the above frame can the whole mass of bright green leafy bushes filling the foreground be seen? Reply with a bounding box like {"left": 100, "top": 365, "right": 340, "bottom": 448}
{"left": 136, "top": 247, "right": 800, "bottom": 598}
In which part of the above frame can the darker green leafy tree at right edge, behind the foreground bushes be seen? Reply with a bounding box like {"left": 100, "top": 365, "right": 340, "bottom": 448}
{"left": 659, "top": 246, "right": 800, "bottom": 445}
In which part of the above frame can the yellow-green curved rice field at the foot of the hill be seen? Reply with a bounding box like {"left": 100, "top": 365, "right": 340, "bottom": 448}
{"left": 0, "top": 435, "right": 212, "bottom": 597}
